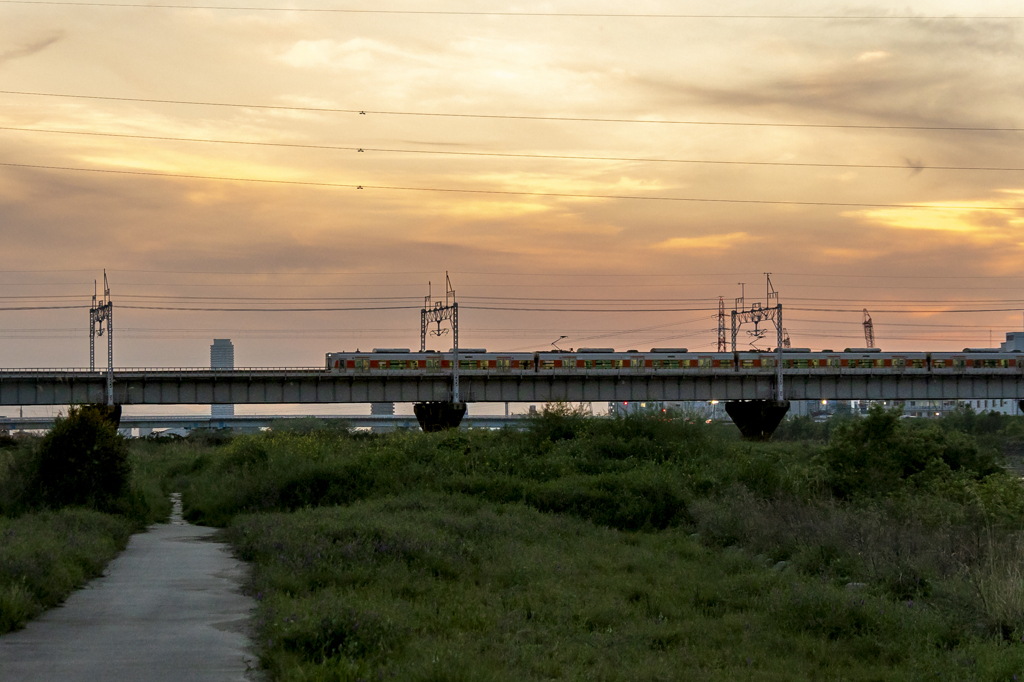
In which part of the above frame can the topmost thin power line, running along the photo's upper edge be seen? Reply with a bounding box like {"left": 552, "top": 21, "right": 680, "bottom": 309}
{"left": 0, "top": 0, "right": 1024, "bottom": 22}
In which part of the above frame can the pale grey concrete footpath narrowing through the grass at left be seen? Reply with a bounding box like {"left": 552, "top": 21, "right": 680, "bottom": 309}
{"left": 0, "top": 499, "right": 258, "bottom": 682}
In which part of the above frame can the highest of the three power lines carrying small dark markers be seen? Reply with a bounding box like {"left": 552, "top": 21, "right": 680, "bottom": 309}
{"left": 0, "top": 89, "right": 1024, "bottom": 132}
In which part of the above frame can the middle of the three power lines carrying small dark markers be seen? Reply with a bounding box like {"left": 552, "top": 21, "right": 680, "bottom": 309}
{"left": 0, "top": 126, "right": 1024, "bottom": 172}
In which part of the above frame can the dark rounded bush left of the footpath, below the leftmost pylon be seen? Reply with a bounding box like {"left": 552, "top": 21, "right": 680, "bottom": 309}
{"left": 36, "top": 407, "right": 131, "bottom": 513}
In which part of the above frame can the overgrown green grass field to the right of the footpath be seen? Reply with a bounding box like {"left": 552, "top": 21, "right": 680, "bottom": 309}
{"left": 155, "top": 409, "right": 1024, "bottom": 681}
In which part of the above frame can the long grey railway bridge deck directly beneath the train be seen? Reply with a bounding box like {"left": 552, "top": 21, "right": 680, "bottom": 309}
{"left": 0, "top": 368, "right": 1024, "bottom": 406}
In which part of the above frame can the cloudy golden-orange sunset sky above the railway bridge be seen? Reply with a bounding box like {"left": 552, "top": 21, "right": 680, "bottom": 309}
{"left": 0, "top": 0, "right": 1024, "bottom": 382}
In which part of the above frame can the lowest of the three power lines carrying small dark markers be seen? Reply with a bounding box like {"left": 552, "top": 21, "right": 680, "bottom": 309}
{"left": 0, "top": 162, "right": 1024, "bottom": 212}
